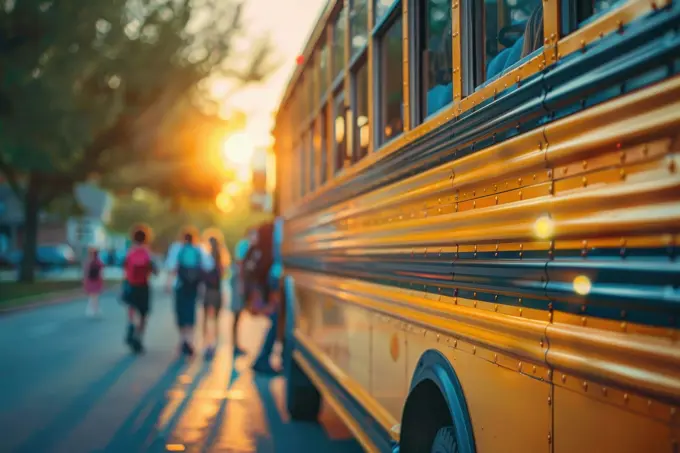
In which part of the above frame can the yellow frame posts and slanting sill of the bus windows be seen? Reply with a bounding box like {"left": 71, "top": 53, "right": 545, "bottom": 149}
{"left": 276, "top": 0, "right": 652, "bottom": 213}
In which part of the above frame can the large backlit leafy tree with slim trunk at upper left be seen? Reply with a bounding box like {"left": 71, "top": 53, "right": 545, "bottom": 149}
{"left": 0, "top": 0, "right": 269, "bottom": 281}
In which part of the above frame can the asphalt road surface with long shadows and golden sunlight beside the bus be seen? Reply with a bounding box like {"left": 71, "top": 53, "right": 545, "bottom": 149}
{"left": 0, "top": 286, "right": 362, "bottom": 453}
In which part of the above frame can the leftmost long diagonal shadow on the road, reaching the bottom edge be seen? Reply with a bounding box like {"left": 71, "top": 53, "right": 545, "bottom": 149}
{"left": 15, "top": 356, "right": 135, "bottom": 453}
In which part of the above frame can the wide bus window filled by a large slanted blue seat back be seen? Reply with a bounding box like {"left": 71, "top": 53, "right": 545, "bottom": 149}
{"left": 476, "top": 0, "right": 543, "bottom": 85}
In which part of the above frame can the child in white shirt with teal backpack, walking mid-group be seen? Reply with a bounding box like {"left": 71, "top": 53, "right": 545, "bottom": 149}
{"left": 166, "top": 228, "right": 214, "bottom": 355}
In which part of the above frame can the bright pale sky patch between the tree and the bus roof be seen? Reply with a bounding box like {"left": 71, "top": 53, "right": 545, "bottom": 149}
{"left": 215, "top": 0, "right": 327, "bottom": 146}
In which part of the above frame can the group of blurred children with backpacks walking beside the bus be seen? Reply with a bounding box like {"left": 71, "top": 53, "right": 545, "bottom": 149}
{"left": 84, "top": 220, "right": 282, "bottom": 374}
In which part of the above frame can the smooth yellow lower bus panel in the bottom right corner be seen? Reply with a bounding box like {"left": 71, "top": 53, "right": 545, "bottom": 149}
{"left": 555, "top": 386, "right": 677, "bottom": 453}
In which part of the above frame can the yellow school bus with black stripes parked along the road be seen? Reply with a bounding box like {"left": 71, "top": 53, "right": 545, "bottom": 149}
{"left": 275, "top": 0, "right": 680, "bottom": 453}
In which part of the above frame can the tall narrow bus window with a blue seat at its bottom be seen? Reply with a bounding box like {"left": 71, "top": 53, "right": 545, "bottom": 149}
{"left": 415, "top": 0, "right": 453, "bottom": 122}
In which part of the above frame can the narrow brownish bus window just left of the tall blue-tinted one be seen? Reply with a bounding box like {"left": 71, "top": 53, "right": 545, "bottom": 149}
{"left": 377, "top": 11, "right": 404, "bottom": 144}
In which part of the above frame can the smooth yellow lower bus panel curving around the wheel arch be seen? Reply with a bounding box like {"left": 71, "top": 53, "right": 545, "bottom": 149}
{"left": 406, "top": 329, "right": 552, "bottom": 453}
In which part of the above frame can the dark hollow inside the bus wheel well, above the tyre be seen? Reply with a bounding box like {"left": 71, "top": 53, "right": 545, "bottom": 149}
{"left": 399, "top": 379, "right": 453, "bottom": 453}
